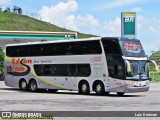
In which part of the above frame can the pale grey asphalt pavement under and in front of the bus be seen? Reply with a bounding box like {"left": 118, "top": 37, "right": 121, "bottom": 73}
{"left": 0, "top": 81, "right": 160, "bottom": 120}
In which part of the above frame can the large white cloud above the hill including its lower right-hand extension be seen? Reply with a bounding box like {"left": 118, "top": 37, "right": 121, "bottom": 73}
{"left": 39, "top": 0, "right": 99, "bottom": 31}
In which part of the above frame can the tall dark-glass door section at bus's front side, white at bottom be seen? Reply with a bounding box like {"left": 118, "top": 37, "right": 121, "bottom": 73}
{"left": 102, "top": 38, "right": 125, "bottom": 92}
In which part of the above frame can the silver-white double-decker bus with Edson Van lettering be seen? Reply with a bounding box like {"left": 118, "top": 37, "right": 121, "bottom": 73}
{"left": 5, "top": 37, "right": 156, "bottom": 95}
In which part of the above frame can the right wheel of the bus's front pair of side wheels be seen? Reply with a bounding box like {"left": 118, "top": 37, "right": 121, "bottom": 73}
{"left": 95, "top": 82, "right": 105, "bottom": 95}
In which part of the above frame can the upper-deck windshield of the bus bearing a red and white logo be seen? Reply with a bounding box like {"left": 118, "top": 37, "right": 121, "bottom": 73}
{"left": 119, "top": 40, "right": 146, "bottom": 57}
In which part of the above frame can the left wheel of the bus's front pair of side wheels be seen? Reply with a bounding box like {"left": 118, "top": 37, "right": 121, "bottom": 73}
{"left": 79, "top": 81, "right": 90, "bottom": 95}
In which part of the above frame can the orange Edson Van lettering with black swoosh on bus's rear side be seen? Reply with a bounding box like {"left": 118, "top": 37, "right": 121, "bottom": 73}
{"left": 8, "top": 58, "right": 32, "bottom": 76}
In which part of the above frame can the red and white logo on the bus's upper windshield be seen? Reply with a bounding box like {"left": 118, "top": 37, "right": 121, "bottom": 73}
{"left": 124, "top": 42, "right": 141, "bottom": 53}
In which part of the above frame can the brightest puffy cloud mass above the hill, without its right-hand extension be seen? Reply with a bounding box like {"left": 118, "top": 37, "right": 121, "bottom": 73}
{"left": 39, "top": 0, "right": 78, "bottom": 27}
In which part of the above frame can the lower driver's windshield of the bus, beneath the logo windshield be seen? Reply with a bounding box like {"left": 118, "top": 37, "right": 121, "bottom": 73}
{"left": 126, "top": 60, "right": 148, "bottom": 80}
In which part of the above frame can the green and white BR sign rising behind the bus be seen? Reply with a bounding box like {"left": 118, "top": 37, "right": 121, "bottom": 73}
{"left": 121, "top": 12, "right": 136, "bottom": 38}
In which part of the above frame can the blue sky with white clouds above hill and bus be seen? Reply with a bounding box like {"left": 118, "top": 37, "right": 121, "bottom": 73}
{"left": 0, "top": 0, "right": 160, "bottom": 55}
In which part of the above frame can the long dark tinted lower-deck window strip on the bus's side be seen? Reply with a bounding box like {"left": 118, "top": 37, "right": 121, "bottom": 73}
{"left": 34, "top": 64, "right": 91, "bottom": 77}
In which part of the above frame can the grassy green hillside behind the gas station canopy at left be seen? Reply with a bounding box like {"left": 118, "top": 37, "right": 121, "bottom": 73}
{"left": 0, "top": 12, "right": 94, "bottom": 38}
